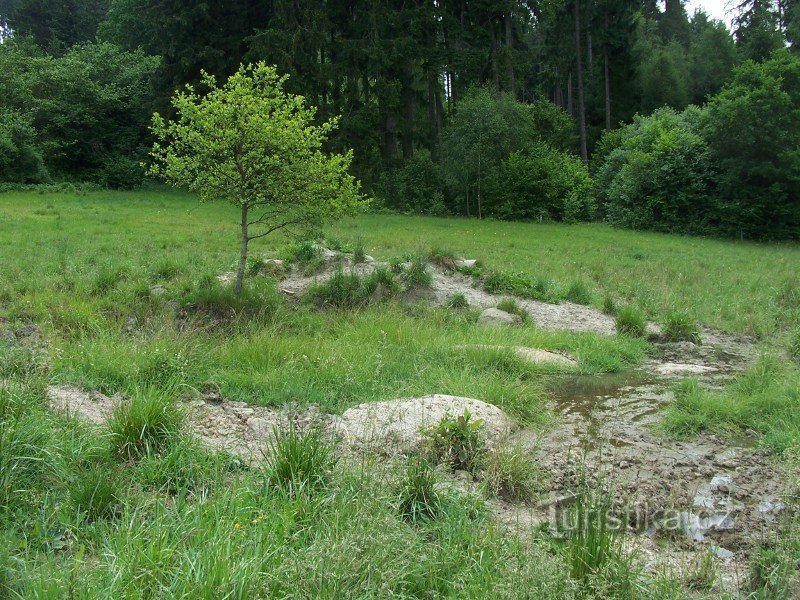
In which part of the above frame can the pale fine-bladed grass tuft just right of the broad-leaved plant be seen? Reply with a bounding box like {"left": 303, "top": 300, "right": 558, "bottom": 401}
{"left": 484, "top": 446, "right": 543, "bottom": 502}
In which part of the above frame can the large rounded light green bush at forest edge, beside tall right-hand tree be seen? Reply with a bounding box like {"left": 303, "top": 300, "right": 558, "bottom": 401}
{"left": 595, "top": 108, "right": 719, "bottom": 233}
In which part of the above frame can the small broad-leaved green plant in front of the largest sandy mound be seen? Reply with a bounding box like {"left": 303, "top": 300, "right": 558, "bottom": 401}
{"left": 427, "top": 409, "right": 486, "bottom": 474}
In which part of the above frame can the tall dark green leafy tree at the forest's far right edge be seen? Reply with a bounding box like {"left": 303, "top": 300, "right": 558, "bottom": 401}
{"left": 702, "top": 51, "right": 800, "bottom": 238}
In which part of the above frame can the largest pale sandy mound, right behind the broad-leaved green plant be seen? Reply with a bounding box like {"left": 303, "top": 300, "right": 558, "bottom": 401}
{"left": 333, "top": 394, "right": 512, "bottom": 455}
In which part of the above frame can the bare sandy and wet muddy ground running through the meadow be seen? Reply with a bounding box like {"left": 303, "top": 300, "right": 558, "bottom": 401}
{"left": 43, "top": 251, "right": 784, "bottom": 589}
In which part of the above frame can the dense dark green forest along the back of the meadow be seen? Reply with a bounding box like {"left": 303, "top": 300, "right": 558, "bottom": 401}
{"left": 0, "top": 0, "right": 800, "bottom": 238}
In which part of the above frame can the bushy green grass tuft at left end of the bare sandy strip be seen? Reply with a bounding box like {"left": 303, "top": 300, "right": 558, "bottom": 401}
{"left": 108, "top": 387, "right": 183, "bottom": 459}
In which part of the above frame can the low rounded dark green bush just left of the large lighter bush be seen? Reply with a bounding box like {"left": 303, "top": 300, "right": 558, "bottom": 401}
{"left": 487, "top": 143, "right": 594, "bottom": 222}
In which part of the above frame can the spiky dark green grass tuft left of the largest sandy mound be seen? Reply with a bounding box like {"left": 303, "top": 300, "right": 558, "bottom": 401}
{"left": 264, "top": 424, "right": 336, "bottom": 498}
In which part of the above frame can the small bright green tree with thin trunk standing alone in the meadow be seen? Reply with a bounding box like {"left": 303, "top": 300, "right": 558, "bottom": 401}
{"left": 149, "top": 63, "right": 365, "bottom": 294}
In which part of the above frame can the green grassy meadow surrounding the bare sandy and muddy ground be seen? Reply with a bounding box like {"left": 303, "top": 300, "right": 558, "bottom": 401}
{"left": 0, "top": 188, "right": 800, "bottom": 599}
